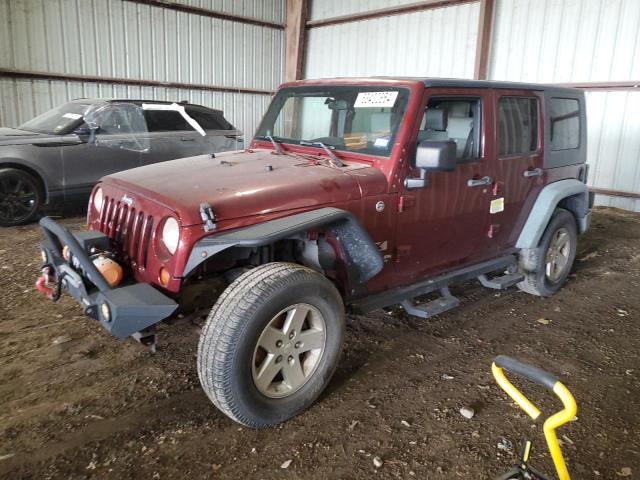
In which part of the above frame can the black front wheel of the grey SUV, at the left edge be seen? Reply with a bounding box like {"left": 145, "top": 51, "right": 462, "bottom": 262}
{"left": 0, "top": 168, "right": 42, "bottom": 227}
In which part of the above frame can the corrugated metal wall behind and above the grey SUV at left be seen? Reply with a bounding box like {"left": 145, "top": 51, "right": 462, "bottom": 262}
{"left": 0, "top": 0, "right": 286, "bottom": 135}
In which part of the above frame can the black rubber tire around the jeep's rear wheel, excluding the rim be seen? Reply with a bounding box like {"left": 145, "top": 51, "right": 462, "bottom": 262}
{"left": 518, "top": 208, "right": 578, "bottom": 297}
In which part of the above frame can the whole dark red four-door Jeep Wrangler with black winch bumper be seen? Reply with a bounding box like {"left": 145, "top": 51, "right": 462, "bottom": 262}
{"left": 39, "top": 78, "right": 592, "bottom": 427}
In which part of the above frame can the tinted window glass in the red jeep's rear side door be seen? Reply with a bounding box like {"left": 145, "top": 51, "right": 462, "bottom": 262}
{"left": 498, "top": 97, "right": 538, "bottom": 157}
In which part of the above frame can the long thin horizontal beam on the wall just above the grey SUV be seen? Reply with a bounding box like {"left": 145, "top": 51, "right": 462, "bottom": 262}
{"left": 0, "top": 68, "right": 274, "bottom": 95}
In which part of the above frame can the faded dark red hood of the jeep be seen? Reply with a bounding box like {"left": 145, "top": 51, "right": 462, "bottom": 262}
{"left": 103, "top": 150, "right": 386, "bottom": 226}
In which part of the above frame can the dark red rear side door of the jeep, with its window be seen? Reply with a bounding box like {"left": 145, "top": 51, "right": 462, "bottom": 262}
{"left": 488, "top": 90, "right": 544, "bottom": 253}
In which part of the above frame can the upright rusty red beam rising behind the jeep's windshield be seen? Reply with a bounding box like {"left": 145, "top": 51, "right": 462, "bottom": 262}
{"left": 284, "top": 0, "right": 307, "bottom": 82}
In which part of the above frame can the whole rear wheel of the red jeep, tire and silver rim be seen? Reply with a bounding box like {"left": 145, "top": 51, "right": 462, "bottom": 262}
{"left": 518, "top": 208, "right": 578, "bottom": 297}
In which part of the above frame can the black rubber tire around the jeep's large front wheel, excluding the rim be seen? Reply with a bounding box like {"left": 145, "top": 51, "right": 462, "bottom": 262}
{"left": 198, "top": 263, "right": 345, "bottom": 428}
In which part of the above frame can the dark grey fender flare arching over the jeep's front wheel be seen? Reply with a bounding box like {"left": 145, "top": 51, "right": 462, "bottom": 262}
{"left": 182, "top": 207, "right": 384, "bottom": 285}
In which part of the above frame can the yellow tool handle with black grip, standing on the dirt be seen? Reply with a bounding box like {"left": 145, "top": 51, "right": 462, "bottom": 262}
{"left": 491, "top": 355, "right": 578, "bottom": 480}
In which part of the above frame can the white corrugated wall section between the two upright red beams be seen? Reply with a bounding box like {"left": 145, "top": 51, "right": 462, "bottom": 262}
{"left": 305, "top": 0, "right": 479, "bottom": 78}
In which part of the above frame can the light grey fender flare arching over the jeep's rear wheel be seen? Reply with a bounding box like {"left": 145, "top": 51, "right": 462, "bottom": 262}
{"left": 516, "top": 179, "right": 590, "bottom": 249}
